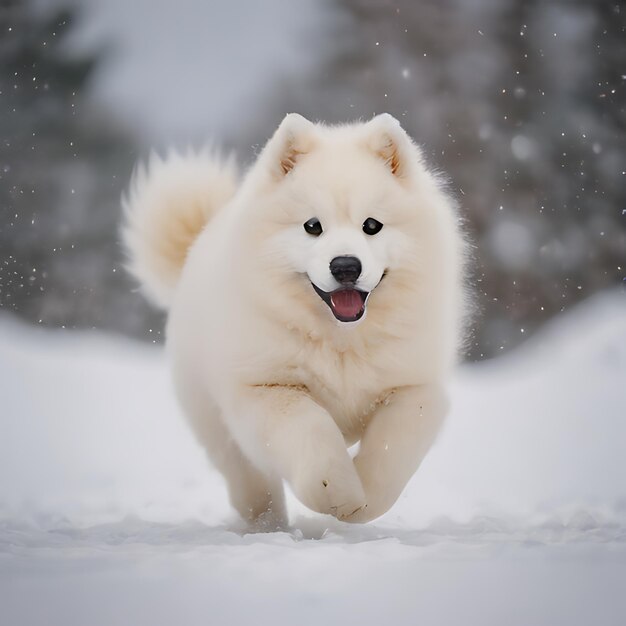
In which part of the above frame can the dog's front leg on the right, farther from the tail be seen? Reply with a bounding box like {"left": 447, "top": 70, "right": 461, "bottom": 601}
{"left": 345, "top": 385, "right": 448, "bottom": 522}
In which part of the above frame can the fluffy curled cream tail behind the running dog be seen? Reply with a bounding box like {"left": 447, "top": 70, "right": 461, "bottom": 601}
{"left": 122, "top": 151, "right": 237, "bottom": 308}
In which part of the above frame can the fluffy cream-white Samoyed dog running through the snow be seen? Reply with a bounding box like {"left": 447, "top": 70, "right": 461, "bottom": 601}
{"left": 124, "top": 114, "right": 465, "bottom": 523}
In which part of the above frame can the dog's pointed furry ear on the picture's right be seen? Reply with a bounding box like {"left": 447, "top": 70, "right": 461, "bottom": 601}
{"left": 365, "top": 113, "right": 414, "bottom": 178}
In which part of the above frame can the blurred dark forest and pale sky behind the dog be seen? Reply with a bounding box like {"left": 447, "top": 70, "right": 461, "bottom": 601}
{"left": 0, "top": 0, "right": 626, "bottom": 360}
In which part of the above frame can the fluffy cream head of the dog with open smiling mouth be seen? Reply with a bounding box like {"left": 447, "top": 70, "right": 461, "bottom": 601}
{"left": 239, "top": 114, "right": 458, "bottom": 334}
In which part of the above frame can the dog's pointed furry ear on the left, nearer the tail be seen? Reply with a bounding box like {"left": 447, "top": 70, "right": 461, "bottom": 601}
{"left": 266, "top": 113, "right": 315, "bottom": 179}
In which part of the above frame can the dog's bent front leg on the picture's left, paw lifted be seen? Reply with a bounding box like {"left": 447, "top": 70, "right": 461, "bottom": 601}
{"left": 232, "top": 385, "right": 365, "bottom": 519}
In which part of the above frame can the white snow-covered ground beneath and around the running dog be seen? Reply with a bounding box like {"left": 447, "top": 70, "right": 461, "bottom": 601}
{"left": 0, "top": 292, "right": 626, "bottom": 626}
